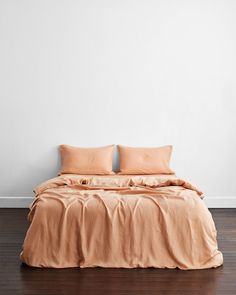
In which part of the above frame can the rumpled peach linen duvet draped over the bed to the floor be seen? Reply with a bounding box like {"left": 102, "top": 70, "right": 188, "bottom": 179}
{"left": 21, "top": 174, "right": 223, "bottom": 269}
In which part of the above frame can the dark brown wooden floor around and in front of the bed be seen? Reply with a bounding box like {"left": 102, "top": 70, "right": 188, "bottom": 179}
{"left": 0, "top": 209, "right": 236, "bottom": 295}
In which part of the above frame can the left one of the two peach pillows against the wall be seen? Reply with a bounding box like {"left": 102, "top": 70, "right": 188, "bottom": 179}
{"left": 59, "top": 145, "right": 114, "bottom": 175}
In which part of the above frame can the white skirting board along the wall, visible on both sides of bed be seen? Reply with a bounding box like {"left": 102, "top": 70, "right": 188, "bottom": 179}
{"left": 0, "top": 196, "right": 236, "bottom": 208}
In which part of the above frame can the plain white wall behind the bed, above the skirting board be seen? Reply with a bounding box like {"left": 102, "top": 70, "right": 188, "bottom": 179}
{"left": 0, "top": 0, "right": 236, "bottom": 197}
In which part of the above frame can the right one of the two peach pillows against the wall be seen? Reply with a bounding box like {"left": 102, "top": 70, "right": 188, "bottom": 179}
{"left": 118, "top": 145, "right": 174, "bottom": 174}
